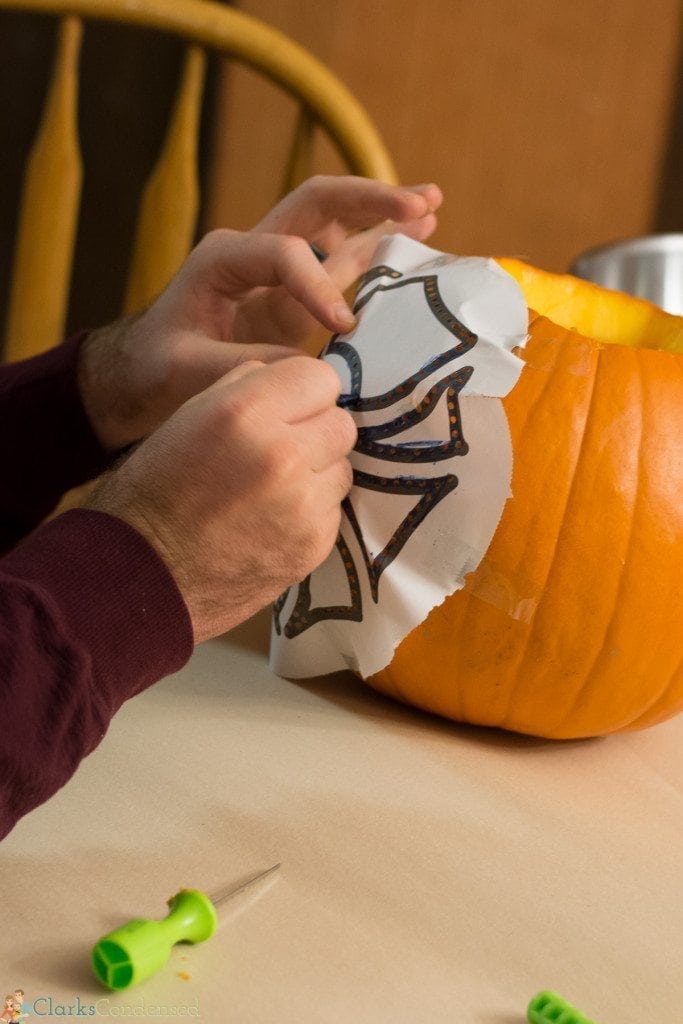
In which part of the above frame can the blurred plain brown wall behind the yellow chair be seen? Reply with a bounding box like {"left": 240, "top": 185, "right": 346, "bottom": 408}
{"left": 207, "top": 0, "right": 682, "bottom": 268}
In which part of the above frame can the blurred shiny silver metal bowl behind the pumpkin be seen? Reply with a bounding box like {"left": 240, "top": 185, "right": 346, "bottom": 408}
{"left": 571, "top": 234, "right": 683, "bottom": 315}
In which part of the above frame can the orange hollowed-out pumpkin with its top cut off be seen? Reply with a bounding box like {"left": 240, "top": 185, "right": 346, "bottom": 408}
{"left": 369, "top": 260, "right": 683, "bottom": 738}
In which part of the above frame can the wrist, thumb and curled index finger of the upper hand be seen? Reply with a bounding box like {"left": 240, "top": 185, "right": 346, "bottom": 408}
{"left": 79, "top": 230, "right": 354, "bottom": 452}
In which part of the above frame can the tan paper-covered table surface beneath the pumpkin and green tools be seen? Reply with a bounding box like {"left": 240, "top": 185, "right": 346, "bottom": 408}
{"left": 0, "top": 614, "right": 683, "bottom": 1024}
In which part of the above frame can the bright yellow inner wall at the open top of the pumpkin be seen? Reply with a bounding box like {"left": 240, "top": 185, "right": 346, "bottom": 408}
{"left": 497, "top": 257, "right": 683, "bottom": 354}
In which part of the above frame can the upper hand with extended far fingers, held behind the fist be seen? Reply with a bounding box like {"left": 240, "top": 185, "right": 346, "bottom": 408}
{"left": 79, "top": 177, "right": 441, "bottom": 451}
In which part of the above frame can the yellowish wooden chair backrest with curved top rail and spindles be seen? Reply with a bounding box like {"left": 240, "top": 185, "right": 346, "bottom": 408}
{"left": 0, "top": 0, "right": 396, "bottom": 360}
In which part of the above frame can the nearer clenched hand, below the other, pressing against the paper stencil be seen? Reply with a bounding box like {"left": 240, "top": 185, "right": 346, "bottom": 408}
{"left": 87, "top": 356, "right": 356, "bottom": 643}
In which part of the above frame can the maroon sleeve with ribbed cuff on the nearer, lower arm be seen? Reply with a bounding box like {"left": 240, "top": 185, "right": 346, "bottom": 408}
{"left": 0, "top": 509, "right": 193, "bottom": 838}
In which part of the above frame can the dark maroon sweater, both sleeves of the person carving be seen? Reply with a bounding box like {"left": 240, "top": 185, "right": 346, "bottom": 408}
{"left": 0, "top": 336, "right": 193, "bottom": 839}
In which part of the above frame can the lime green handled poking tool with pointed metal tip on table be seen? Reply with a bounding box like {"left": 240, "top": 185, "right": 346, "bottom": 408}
{"left": 92, "top": 864, "right": 280, "bottom": 989}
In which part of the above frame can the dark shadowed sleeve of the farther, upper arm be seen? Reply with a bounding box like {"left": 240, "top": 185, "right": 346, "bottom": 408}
{"left": 0, "top": 333, "right": 113, "bottom": 551}
